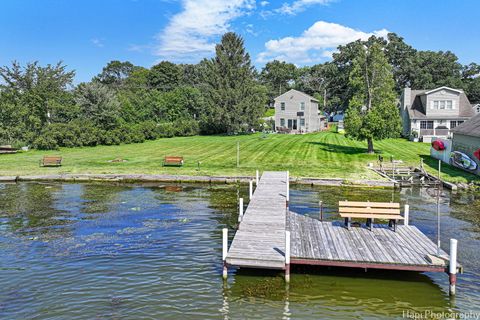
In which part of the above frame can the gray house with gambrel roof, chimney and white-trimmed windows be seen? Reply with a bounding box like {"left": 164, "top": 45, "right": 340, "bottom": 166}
{"left": 400, "top": 87, "right": 475, "bottom": 142}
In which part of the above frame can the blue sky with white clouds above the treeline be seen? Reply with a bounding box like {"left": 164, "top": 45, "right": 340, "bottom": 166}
{"left": 0, "top": 0, "right": 480, "bottom": 82}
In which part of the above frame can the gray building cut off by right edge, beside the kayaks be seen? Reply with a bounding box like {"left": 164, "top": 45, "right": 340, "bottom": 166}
{"left": 452, "top": 114, "right": 480, "bottom": 174}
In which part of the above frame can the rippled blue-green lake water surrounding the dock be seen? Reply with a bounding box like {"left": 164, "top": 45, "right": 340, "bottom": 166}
{"left": 0, "top": 183, "right": 480, "bottom": 319}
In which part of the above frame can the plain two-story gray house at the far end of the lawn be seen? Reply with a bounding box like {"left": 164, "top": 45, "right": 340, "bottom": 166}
{"left": 275, "top": 89, "right": 324, "bottom": 133}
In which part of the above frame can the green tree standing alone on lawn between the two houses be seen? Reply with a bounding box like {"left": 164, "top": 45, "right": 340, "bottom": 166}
{"left": 345, "top": 42, "right": 401, "bottom": 153}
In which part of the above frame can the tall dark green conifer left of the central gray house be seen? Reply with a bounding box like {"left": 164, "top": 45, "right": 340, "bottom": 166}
{"left": 201, "top": 32, "right": 267, "bottom": 134}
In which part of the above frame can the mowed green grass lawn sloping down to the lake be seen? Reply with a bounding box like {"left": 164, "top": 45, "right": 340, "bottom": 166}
{"left": 0, "top": 132, "right": 478, "bottom": 182}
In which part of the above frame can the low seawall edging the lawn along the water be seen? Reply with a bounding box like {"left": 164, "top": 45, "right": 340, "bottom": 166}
{"left": 0, "top": 173, "right": 395, "bottom": 188}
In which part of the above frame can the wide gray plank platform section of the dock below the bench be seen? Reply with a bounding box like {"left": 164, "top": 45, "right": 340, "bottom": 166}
{"left": 288, "top": 212, "right": 448, "bottom": 272}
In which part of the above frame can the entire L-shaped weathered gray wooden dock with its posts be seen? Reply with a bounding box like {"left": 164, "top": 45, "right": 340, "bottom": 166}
{"left": 223, "top": 172, "right": 459, "bottom": 294}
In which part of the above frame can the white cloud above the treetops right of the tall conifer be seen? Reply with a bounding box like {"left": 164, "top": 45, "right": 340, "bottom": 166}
{"left": 257, "top": 21, "right": 388, "bottom": 64}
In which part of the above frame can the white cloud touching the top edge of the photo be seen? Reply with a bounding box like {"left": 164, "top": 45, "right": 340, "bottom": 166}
{"left": 154, "top": 0, "right": 255, "bottom": 61}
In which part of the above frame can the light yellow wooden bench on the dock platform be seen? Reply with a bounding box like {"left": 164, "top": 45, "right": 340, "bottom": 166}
{"left": 338, "top": 201, "right": 404, "bottom": 231}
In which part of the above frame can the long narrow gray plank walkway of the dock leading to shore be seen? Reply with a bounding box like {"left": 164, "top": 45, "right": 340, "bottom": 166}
{"left": 226, "top": 172, "right": 287, "bottom": 269}
